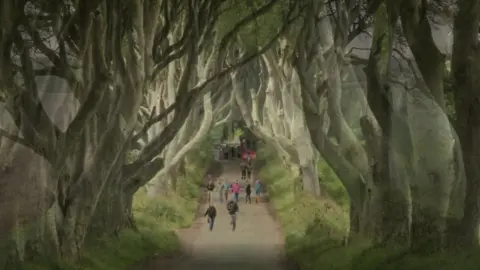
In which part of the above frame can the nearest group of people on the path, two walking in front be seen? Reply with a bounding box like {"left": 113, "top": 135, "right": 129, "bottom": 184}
{"left": 205, "top": 176, "right": 262, "bottom": 231}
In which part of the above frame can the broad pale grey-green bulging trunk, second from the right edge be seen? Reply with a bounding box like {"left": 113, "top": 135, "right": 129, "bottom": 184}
{"left": 407, "top": 89, "right": 457, "bottom": 252}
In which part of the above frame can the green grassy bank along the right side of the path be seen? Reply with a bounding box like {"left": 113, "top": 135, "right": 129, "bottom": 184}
{"left": 260, "top": 148, "right": 480, "bottom": 270}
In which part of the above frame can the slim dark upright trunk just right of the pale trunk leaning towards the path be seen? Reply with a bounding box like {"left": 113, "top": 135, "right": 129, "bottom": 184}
{"left": 360, "top": 4, "right": 410, "bottom": 244}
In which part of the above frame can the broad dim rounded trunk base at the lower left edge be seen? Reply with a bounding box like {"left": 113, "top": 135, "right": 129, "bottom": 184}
{"left": 0, "top": 144, "right": 58, "bottom": 266}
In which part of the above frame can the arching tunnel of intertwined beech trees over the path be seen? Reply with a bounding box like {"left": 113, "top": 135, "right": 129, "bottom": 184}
{"left": 0, "top": 0, "right": 480, "bottom": 266}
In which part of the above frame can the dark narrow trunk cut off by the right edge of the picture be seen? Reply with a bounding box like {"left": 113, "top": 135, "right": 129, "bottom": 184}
{"left": 452, "top": 1, "right": 480, "bottom": 247}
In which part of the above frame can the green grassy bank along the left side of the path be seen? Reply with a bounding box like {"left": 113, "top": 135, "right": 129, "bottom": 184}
{"left": 17, "top": 162, "right": 204, "bottom": 270}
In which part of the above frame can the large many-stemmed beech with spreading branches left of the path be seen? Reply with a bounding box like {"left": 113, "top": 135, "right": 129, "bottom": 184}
{"left": 1, "top": 0, "right": 300, "bottom": 260}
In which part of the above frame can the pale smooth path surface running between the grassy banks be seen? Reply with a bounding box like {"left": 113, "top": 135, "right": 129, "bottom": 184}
{"left": 139, "top": 162, "right": 286, "bottom": 270}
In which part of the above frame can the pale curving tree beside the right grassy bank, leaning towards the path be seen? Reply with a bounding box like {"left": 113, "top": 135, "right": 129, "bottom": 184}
{"left": 293, "top": 1, "right": 381, "bottom": 239}
